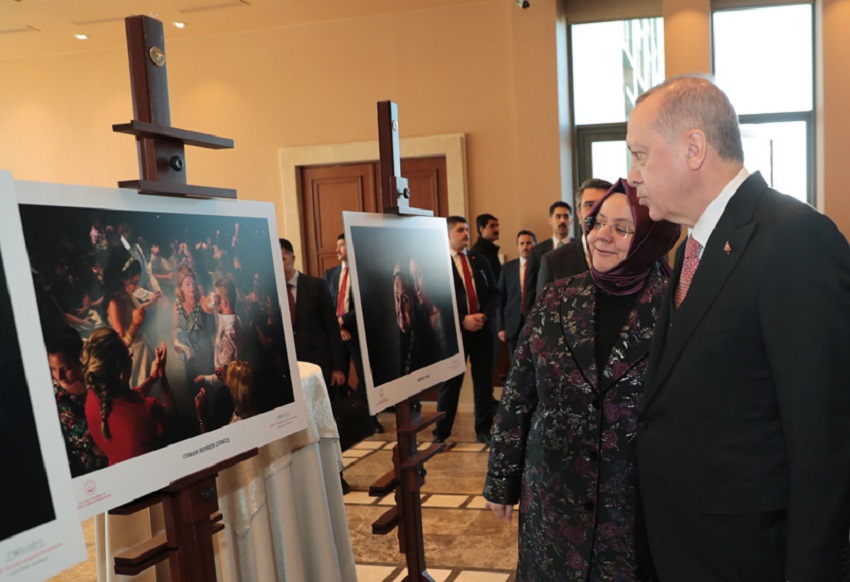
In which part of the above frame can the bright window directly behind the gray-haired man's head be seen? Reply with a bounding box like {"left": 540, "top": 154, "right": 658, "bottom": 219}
{"left": 712, "top": 4, "right": 814, "bottom": 203}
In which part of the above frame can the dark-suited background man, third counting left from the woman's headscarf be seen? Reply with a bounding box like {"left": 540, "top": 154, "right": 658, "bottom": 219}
{"left": 496, "top": 230, "right": 537, "bottom": 361}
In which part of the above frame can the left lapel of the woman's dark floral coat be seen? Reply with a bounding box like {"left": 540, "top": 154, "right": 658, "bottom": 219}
{"left": 560, "top": 275, "right": 599, "bottom": 389}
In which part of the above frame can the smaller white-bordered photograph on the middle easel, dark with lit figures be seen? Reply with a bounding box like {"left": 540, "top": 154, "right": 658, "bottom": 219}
{"left": 343, "top": 212, "right": 465, "bottom": 414}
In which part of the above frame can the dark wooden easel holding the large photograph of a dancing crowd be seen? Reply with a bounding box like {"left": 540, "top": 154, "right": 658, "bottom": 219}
{"left": 110, "top": 16, "right": 252, "bottom": 582}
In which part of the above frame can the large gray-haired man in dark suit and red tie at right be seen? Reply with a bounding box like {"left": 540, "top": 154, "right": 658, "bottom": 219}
{"left": 626, "top": 76, "right": 850, "bottom": 582}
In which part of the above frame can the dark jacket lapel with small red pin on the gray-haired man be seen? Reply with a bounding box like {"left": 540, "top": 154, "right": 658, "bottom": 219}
{"left": 645, "top": 173, "right": 767, "bottom": 404}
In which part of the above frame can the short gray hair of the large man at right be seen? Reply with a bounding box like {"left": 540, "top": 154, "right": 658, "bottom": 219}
{"left": 636, "top": 75, "right": 744, "bottom": 163}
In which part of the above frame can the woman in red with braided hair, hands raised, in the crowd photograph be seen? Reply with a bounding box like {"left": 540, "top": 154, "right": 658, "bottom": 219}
{"left": 82, "top": 327, "right": 175, "bottom": 466}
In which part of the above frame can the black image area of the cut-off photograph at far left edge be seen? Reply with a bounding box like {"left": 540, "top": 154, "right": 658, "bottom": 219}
{"left": 0, "top": 249, "right": 55, "bottom": 540}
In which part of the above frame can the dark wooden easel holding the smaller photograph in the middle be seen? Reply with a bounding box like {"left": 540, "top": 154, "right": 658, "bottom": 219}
{"left": 369, "top": 101, "right": 446, "bottom": 582}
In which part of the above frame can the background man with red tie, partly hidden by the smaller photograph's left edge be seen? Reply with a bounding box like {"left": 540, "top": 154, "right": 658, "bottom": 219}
{"left": 325, "top": 233, "right": 384, "bottom": 433}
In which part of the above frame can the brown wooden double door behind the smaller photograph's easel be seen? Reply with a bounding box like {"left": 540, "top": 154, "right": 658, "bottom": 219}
{"left": 299, "top": 156, "right": 449, "bottom": 277}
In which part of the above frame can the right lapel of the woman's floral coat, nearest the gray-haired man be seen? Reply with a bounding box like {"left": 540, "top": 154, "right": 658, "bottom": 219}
{"left": 601, "top": 272, "right": 664, "bottom": 391}
